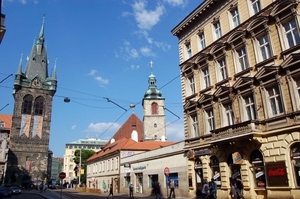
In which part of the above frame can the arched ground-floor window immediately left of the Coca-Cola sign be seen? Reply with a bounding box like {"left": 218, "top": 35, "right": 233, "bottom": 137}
{"left": 250, "top": 150, "right": 266, "bottom": 187}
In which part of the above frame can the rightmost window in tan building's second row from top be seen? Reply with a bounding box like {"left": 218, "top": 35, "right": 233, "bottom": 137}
{"left": 284, "top": 19, "right": 300, "bottom": 48}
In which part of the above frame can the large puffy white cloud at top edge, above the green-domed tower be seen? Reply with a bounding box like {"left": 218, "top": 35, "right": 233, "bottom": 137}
{"left": 132, "top": 1, "right": 164, "bottom": 30}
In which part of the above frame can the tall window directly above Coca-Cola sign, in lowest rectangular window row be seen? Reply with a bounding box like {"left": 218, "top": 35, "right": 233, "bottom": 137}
{"left": 267, "top": 87, "right": 283, "bottom": 116}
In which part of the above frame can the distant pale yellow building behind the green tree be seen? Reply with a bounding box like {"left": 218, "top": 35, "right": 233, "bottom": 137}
{"left": 62, "top": 138, "right": 108, "bottom": 183}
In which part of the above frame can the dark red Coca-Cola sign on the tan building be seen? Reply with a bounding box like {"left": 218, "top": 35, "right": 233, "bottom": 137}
{"left": 266, "top": 162, "right": 289, "bottom": 187}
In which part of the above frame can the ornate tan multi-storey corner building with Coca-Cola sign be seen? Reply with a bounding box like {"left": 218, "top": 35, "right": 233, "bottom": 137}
{"left": 171, "top": 0, "right": 300, "bottom": 199}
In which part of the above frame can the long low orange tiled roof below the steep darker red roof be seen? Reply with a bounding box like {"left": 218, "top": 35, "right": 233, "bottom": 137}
{"left": 87, "top": 138, "right": 174, "bottom": 162}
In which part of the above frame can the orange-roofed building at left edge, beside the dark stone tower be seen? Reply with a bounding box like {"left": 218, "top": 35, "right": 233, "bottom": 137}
{"left": 0, "top": 114, "right": 12, "bottom": 184}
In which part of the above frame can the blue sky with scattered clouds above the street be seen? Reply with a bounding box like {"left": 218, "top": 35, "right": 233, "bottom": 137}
{"left": 0, "top": 0, "right": 202, "bottom": 157}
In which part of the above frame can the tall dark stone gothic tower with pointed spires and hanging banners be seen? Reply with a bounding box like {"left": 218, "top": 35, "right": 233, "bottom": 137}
{"left": 5, "top": 19, "right": 57, "bottom": 183}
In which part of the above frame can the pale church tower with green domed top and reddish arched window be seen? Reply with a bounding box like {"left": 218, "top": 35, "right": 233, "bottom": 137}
{"left": 143, "top": 62, "right": 166, "bottom": 141}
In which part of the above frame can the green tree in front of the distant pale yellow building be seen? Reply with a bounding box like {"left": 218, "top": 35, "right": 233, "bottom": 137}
{"left": 74, "top": 149, "right": 95, "bottom": 184}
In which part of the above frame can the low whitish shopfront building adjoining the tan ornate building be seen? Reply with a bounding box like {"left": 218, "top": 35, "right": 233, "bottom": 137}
{"left": 120, "top": 142, "right": 188, "bottom": 197}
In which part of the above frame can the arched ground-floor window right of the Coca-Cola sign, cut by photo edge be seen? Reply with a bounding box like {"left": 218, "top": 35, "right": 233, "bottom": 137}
{"left": 291, "top": 142, "right": 300, "bottom": 187}
